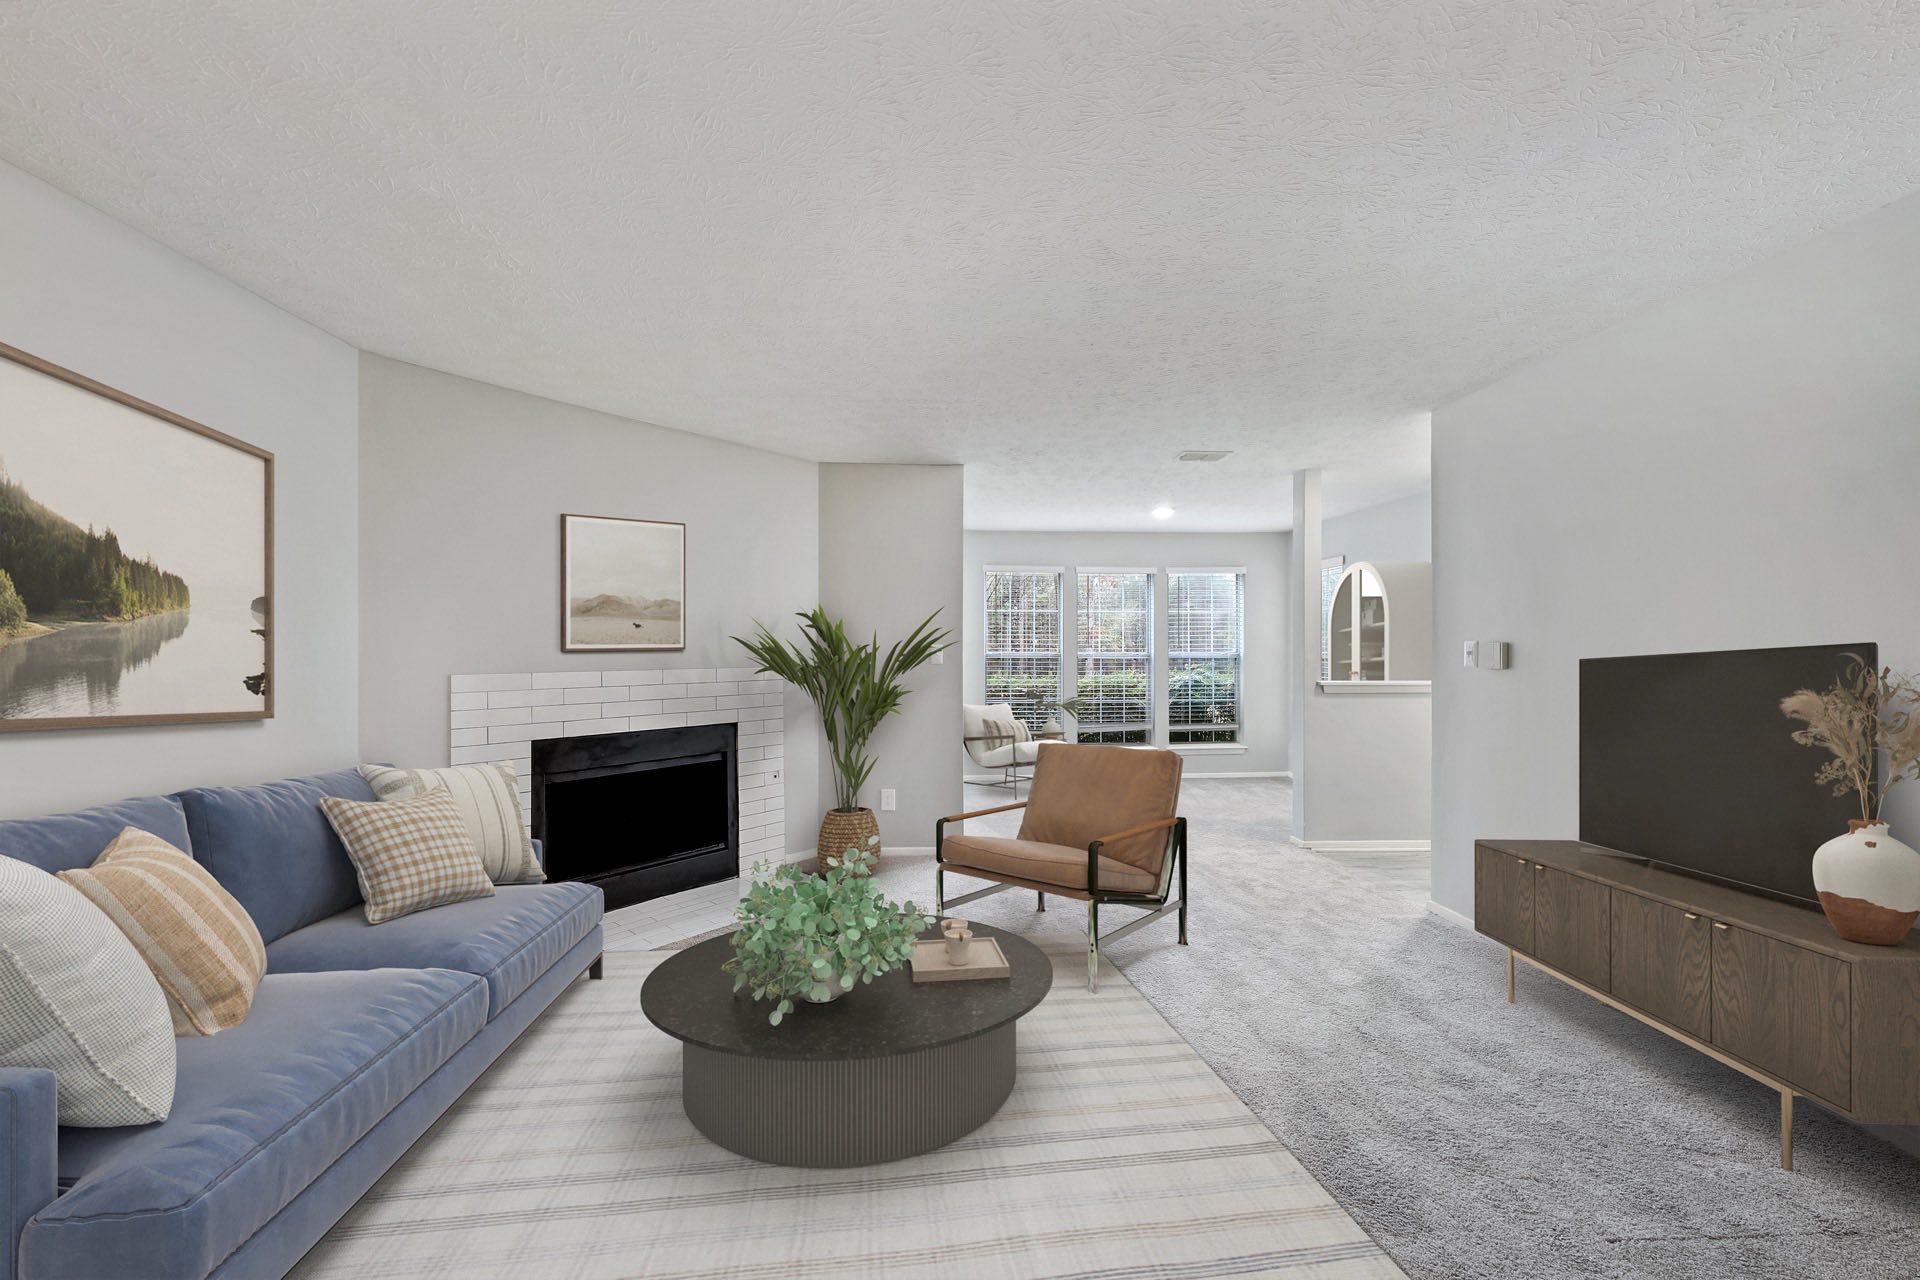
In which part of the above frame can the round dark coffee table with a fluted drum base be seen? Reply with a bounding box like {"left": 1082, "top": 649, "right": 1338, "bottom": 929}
{"left": 639, "top": 925, "right": 1054, "bottom": 1169}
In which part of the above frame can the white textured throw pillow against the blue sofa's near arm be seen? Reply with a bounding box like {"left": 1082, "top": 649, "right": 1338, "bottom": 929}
{"left": 0, "top": 858, "right": 175, "bottom": 1128}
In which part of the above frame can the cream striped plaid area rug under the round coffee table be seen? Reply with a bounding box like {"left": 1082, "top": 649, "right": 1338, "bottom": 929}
{"left": 294, "top": 940, "right": 1402, "bottom": 1280}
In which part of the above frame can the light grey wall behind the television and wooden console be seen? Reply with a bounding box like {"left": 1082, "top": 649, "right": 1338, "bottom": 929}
{"left": 1432, "top": 189, "right": 1920, "bottom": 913}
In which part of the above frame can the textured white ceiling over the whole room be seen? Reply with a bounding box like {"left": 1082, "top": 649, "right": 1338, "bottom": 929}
{"left": 0, "top": 0, "right": 1920, "bottom": 530}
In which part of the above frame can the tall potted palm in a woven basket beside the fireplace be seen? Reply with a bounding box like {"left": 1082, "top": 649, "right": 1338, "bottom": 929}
{"left": 733, "top": 606, "right": 952, "bottom": 873}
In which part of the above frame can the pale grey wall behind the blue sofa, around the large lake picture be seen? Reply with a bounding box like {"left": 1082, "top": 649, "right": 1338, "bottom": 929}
{"left": 0, "top": 165, "right": 359, "bottom": 818}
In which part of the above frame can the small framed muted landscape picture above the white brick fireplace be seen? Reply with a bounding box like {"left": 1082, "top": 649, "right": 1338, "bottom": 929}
{"left": 561, "top": 516, "right": 687, "bottom": 652}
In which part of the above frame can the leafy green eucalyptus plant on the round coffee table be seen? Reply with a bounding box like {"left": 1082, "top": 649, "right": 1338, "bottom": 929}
{"left": 720, "top": 837, "right": 933, "bottom": 1027}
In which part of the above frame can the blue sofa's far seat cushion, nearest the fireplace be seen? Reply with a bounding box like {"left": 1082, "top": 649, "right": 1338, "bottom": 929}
{"left": 267, "top": 881, "right": 603, "bottom": 1021}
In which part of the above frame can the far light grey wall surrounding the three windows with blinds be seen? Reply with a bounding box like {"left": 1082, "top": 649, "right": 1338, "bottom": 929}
{"left": 948, "top": 532, "right": 1290, "bottom": 777}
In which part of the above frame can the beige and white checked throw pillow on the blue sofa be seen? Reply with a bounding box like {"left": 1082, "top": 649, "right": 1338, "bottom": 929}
{"left": 321, "top": 789, "right": 493, "bottom": 925}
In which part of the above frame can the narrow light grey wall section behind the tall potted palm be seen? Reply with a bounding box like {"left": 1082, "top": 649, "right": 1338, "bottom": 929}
{"left": 821, "top": 462, "right": 964, "bottom": 848}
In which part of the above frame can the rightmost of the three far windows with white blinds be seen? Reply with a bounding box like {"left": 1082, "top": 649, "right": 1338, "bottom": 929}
{"left": 1167, "top": 568, "right": 1246, "bottom": 747}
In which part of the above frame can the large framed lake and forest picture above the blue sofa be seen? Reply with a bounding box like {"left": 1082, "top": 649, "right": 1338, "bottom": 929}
{"left": 0, "top": 345, "right": 273, "bottom": 731}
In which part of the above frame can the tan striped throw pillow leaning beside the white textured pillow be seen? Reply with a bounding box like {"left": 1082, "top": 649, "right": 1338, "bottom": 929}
{"left": 60, "top": 827, "right": 267, "bottom": 1036}
